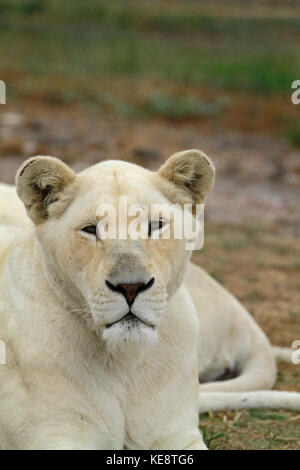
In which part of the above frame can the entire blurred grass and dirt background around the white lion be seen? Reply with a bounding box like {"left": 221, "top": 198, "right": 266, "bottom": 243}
{"left": 0, "top": 0, "right": 300, "bottom": 449}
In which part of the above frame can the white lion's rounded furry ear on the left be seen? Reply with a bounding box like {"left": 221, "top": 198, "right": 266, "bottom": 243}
{"left": 16, "top": 157, "right": 76, "bottom": 224}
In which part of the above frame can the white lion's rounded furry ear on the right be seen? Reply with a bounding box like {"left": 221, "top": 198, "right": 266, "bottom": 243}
{"left": 158, "top": 150, "right": 215, "bottom": 204}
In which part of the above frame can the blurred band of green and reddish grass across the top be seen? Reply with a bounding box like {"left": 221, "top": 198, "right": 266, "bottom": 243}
{"left": 0, "top": 0, "right": 300, "bottom": 136}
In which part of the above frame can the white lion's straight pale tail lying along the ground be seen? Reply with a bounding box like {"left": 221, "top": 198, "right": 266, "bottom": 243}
{"left": 199, "top": 390, "right": 300, "bottom": 413}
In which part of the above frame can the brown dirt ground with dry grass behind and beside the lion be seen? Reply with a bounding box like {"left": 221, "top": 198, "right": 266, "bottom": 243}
{"left": 0, "top": 103, "right": 300, "bottom": 449}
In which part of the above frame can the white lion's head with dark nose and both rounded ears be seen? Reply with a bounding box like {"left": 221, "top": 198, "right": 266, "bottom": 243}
{"left": 16, "top": 150, "right": 214, "bottom": 344}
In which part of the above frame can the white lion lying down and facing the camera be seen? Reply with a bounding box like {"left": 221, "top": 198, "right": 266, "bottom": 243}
{"left": 0, "top": 150, "right": 300, "bottom": 449}
